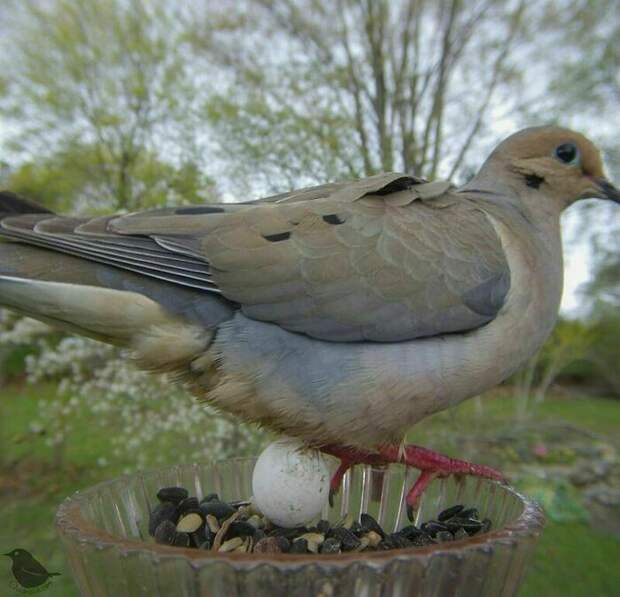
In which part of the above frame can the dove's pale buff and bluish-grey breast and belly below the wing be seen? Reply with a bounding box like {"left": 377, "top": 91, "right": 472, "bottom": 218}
{"left": 196, "top": 210, "right": 562, "bottom": 447}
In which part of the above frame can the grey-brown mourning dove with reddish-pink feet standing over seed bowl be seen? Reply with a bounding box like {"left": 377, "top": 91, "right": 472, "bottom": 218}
{"left": 0, "top": 126, "right": 620, "bottom": 513}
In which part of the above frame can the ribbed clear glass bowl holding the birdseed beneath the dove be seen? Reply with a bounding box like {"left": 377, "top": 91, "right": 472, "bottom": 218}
{"left": 56, "top": 458, "right": 544, "bottom": 597}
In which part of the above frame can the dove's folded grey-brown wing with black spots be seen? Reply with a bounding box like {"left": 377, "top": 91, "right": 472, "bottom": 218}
{"left": 4, "top": 174, "right": 510, "bottom": 341}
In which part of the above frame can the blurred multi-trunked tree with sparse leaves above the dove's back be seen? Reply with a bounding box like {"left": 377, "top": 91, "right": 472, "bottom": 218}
{"left": 194, "top": 0, "right": 531, "bottom": 186}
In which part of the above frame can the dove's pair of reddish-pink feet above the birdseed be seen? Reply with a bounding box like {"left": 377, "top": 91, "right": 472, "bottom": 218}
{"left": 321, "top": 445, "right": 504, "bottom": 519}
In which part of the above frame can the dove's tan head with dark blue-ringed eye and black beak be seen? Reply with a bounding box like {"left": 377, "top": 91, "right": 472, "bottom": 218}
{"left": 489, "top": 126, "right": 620, "bottom": 209}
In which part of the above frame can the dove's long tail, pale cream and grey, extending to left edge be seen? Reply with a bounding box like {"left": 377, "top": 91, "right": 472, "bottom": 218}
{"left": 0, "top": 192, "right": 231, "bottom": 370}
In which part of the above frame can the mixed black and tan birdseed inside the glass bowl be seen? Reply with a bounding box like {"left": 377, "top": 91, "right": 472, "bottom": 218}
{"left": 148, "top": 487, "right": 492, "bottom": 555}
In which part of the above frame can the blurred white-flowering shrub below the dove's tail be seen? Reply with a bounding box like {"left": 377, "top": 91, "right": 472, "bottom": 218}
{"left": 0, "top": 311, "right": 266, "bottom": 472}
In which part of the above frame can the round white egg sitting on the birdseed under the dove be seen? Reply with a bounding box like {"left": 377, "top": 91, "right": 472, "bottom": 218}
{"left": 252, "top": 438, "right": 330, "bottom": 528}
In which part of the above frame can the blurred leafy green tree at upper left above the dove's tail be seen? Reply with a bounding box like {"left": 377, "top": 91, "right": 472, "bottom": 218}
{"left": 0, "top": 0, "right": 211, "bottom": 210}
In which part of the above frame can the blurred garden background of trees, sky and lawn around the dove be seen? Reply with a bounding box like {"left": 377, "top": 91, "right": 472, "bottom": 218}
{"left": 0, "top": 0, "right": 620, "bottom": 597}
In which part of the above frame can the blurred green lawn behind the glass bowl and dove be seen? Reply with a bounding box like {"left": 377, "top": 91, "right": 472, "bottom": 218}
{"left": 0, "top": 385, "right": 620, "bottom": 597}
